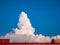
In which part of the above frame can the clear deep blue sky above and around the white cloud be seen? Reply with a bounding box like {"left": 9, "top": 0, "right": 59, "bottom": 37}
{"left": 0, "top": 0, "right": 60, "bottom": 36}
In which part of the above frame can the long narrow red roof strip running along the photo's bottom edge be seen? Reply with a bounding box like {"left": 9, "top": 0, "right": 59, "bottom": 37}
{"left": 0, "top": 43, "right": 60, "bottom": 45}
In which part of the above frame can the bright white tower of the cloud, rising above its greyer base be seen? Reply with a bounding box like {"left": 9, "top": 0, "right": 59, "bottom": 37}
{"left": 15, "top": 12, "right": 34, "bottom": 35}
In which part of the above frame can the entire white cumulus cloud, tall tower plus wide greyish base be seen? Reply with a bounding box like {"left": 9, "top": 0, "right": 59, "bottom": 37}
{"left": 1, "top": 12, "right": 60, "bottom": 43}
